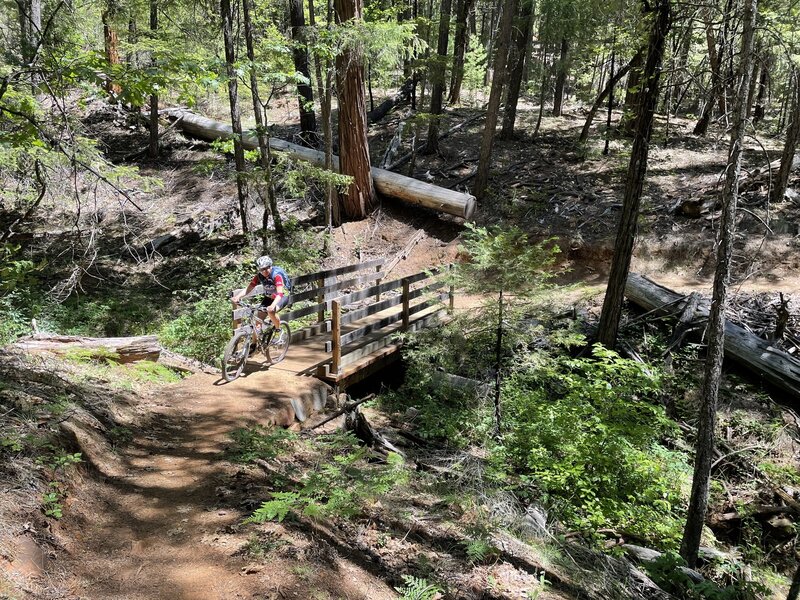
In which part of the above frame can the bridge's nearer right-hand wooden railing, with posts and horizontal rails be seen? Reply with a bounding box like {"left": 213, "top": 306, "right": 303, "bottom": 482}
{"left": 325, "top": 269, "right": 453, "bottom": 376}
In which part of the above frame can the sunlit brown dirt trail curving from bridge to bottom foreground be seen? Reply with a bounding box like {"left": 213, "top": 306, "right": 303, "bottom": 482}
{"left": 53, "top": 363, "right": 396, "bottom": 600}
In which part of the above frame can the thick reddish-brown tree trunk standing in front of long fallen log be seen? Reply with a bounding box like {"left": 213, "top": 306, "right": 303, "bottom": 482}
{"left": 334, "top": 0, "right": 375, "bottom": 220}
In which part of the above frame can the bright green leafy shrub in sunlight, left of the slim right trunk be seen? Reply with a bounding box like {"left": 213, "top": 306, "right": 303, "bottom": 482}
{"left": 503, "top": 346, "right": 688, "bottom": 543}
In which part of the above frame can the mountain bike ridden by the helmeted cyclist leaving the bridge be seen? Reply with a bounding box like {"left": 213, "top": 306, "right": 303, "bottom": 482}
{"left": 222, "top": 303, "right": 292, "bottom": 381}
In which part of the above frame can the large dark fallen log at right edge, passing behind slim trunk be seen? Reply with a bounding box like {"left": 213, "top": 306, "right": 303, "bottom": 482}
{"left": 625, "top": 273, "right": 800, "bottom": 399}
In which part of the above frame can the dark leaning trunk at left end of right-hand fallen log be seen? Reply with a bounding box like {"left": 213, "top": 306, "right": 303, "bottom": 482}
{"left": 597, "top": 0, "right": 670, "bottom": 348}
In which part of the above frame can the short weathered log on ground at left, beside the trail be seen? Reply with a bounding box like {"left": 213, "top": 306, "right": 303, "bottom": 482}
{"left": 12, "top": 333, "right": 161, "bottom": 363}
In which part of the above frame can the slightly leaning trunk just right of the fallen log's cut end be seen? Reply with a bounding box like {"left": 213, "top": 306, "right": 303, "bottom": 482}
{"left": 473, "top": 0, "right": 516, "bottom": 199}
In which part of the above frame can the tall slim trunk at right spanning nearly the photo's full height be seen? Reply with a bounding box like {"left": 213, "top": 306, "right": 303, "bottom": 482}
{"left": 681, "top": 0, "right": 757, "bottom": 568}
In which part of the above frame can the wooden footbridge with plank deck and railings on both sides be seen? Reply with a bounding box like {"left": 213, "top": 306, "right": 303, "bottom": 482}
{"left": 260, "top": 259, "right": 454, "bottom": 389}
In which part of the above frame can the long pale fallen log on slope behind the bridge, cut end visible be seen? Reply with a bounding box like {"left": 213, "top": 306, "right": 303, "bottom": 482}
{"left": 161, "top": 108, "right": 476, "bottom": 219}
